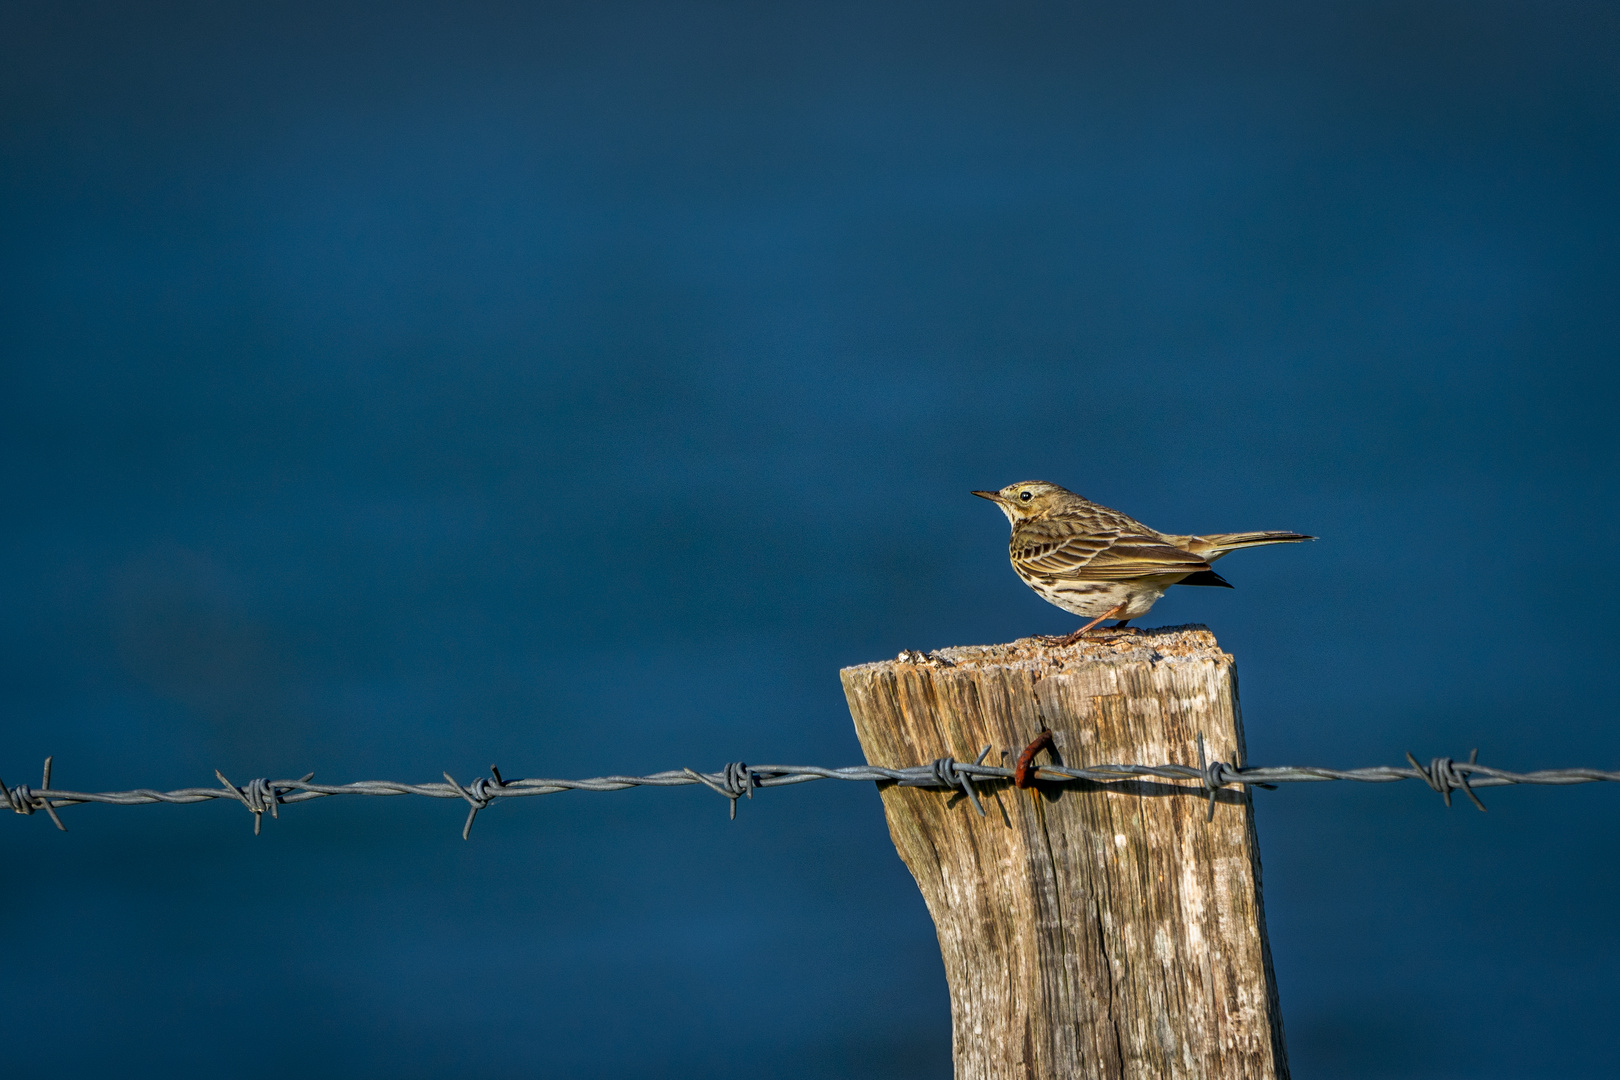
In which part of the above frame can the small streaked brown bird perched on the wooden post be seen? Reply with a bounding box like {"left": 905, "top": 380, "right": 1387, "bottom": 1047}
{"left": 972, "top": 479, "right": 1315, "bottom": 644}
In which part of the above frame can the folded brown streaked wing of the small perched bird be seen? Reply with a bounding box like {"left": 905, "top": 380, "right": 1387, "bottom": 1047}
{"left": 1009, "top": 515, "right": 1210, "bottom": 581}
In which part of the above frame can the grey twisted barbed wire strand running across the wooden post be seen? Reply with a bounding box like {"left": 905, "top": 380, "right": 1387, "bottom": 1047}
{"left": 0, "top": 744, "right": 1620, "bottom": 840}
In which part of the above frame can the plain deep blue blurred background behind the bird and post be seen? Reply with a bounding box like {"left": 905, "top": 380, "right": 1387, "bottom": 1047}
{"left": 0, "top": 2, "right": 1620, "bottom": 1078}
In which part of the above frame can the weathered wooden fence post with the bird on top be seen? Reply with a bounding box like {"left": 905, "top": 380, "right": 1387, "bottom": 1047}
{"left": 841, "top": 627, "right": 1288, "bottom": 1080}
